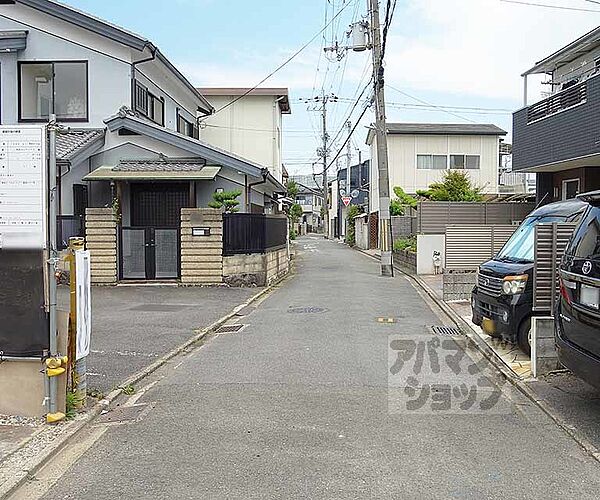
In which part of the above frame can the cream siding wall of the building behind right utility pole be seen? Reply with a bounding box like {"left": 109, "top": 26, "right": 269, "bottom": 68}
{"left": 369, "top": 134, "right": 499, "bottom": 207}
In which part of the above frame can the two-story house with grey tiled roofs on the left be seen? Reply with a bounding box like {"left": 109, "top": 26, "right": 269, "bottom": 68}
{"left": 0, "top": 0, "right": 285, "bottom": 278}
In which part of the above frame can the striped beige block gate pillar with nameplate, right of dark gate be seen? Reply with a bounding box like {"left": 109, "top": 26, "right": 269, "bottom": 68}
{"left": 181, "top": 208, "right": 223, "bottom": 285}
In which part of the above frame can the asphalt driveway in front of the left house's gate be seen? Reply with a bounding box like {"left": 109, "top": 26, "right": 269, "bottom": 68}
{"left": 59, "top": 286, "right": 260, "bottom": 392}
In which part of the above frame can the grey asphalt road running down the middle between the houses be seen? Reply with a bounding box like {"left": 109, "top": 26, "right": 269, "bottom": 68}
{"left": 37, "top": 237, "right": 600, "bottom": 500}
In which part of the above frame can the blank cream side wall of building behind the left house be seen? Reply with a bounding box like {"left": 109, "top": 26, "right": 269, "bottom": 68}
{"left": 200, "top": 95, "right": 283, "bottom": 181}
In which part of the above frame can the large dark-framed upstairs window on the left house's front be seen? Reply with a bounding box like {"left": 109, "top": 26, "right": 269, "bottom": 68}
{"left": 19, "top": 61, "right": 88, "bottom": 121}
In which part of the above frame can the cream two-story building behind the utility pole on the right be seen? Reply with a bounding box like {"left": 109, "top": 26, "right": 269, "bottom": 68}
{"left": 367, "top": 123, "right": 506, "bottom": 212}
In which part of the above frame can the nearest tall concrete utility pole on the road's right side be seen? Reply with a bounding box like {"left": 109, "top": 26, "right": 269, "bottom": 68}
{"left": 368, "top": 0, "right": 394, "bottom": 276}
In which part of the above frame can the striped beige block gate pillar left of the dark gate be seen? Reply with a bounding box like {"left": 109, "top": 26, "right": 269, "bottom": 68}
{"left": 85, "top": 208, "right": 118, "bottom": 285}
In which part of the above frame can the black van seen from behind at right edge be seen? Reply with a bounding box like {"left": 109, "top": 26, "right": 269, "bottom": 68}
{"left": 554, "top": 191, "right": 600, "bottom": 388}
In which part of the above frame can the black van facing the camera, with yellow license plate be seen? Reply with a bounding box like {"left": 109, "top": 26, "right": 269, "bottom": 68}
{"left": 471, "top": 199, "right": 587, "bottom": 354}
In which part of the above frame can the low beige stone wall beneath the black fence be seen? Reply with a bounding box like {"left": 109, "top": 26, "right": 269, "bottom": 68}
{"left": 223, "top": 248, "right": 290, "bottom": 286}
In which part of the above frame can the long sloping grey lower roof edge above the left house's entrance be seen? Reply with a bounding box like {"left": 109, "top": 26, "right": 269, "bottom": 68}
{"left": 105, "top": 108, "right": 286, "bottom": 193}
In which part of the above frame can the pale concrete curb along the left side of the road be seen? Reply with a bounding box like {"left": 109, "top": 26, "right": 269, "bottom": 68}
{"left": 0, "top": 272, "right": 295, "bottom": 499}
